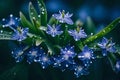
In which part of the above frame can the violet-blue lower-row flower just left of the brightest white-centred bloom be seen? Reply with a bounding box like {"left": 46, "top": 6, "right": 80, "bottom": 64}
{"left": 60, "top": 45, "right": 76, "bottom": 59}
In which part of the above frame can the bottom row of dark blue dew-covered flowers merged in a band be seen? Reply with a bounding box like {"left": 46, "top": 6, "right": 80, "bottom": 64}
{"left": 12, "top": 45, "right": 93, "bottom": 77}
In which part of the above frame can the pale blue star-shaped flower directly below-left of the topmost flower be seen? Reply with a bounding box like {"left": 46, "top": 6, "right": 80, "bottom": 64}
{"left": 46, "top": 25, "right": 63, "bottom": 37}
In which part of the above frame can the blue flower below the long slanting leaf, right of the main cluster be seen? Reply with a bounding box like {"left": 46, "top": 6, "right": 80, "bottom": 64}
{"left": 98, "top": 37, "right": 116, "bottom": 56}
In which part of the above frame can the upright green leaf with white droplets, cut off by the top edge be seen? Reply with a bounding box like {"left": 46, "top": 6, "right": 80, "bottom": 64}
{"left": 38, "top": 0, "right": 47, "bottom": 26}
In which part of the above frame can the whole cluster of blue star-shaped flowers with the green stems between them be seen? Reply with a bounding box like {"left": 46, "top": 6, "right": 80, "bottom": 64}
{"left": 2, "top": 3, "right": 120, "bottom": 77}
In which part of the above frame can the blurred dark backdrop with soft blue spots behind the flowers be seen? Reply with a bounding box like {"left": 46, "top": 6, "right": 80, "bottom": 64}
{"left": 0, "top": 0, "right": 120, "bottom": 80}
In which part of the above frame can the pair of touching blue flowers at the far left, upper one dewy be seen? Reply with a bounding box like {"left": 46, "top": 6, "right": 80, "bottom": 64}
{"left": 2, "top": 14, "right": 29, "bottom": 41}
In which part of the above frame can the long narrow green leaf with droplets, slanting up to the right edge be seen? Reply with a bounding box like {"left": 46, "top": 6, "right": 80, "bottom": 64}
{"left": 83, "top": 18, "right": 120, "bottom": 44}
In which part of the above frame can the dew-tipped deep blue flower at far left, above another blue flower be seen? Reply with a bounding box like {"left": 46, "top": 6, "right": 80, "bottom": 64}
{"left": 2, "top": 14, "right": 20, "bottom": 30}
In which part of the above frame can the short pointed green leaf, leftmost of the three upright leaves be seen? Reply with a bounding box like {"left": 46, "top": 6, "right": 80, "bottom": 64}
{"left": 20, "top": 12, "right": 36, "bottom": 32}
